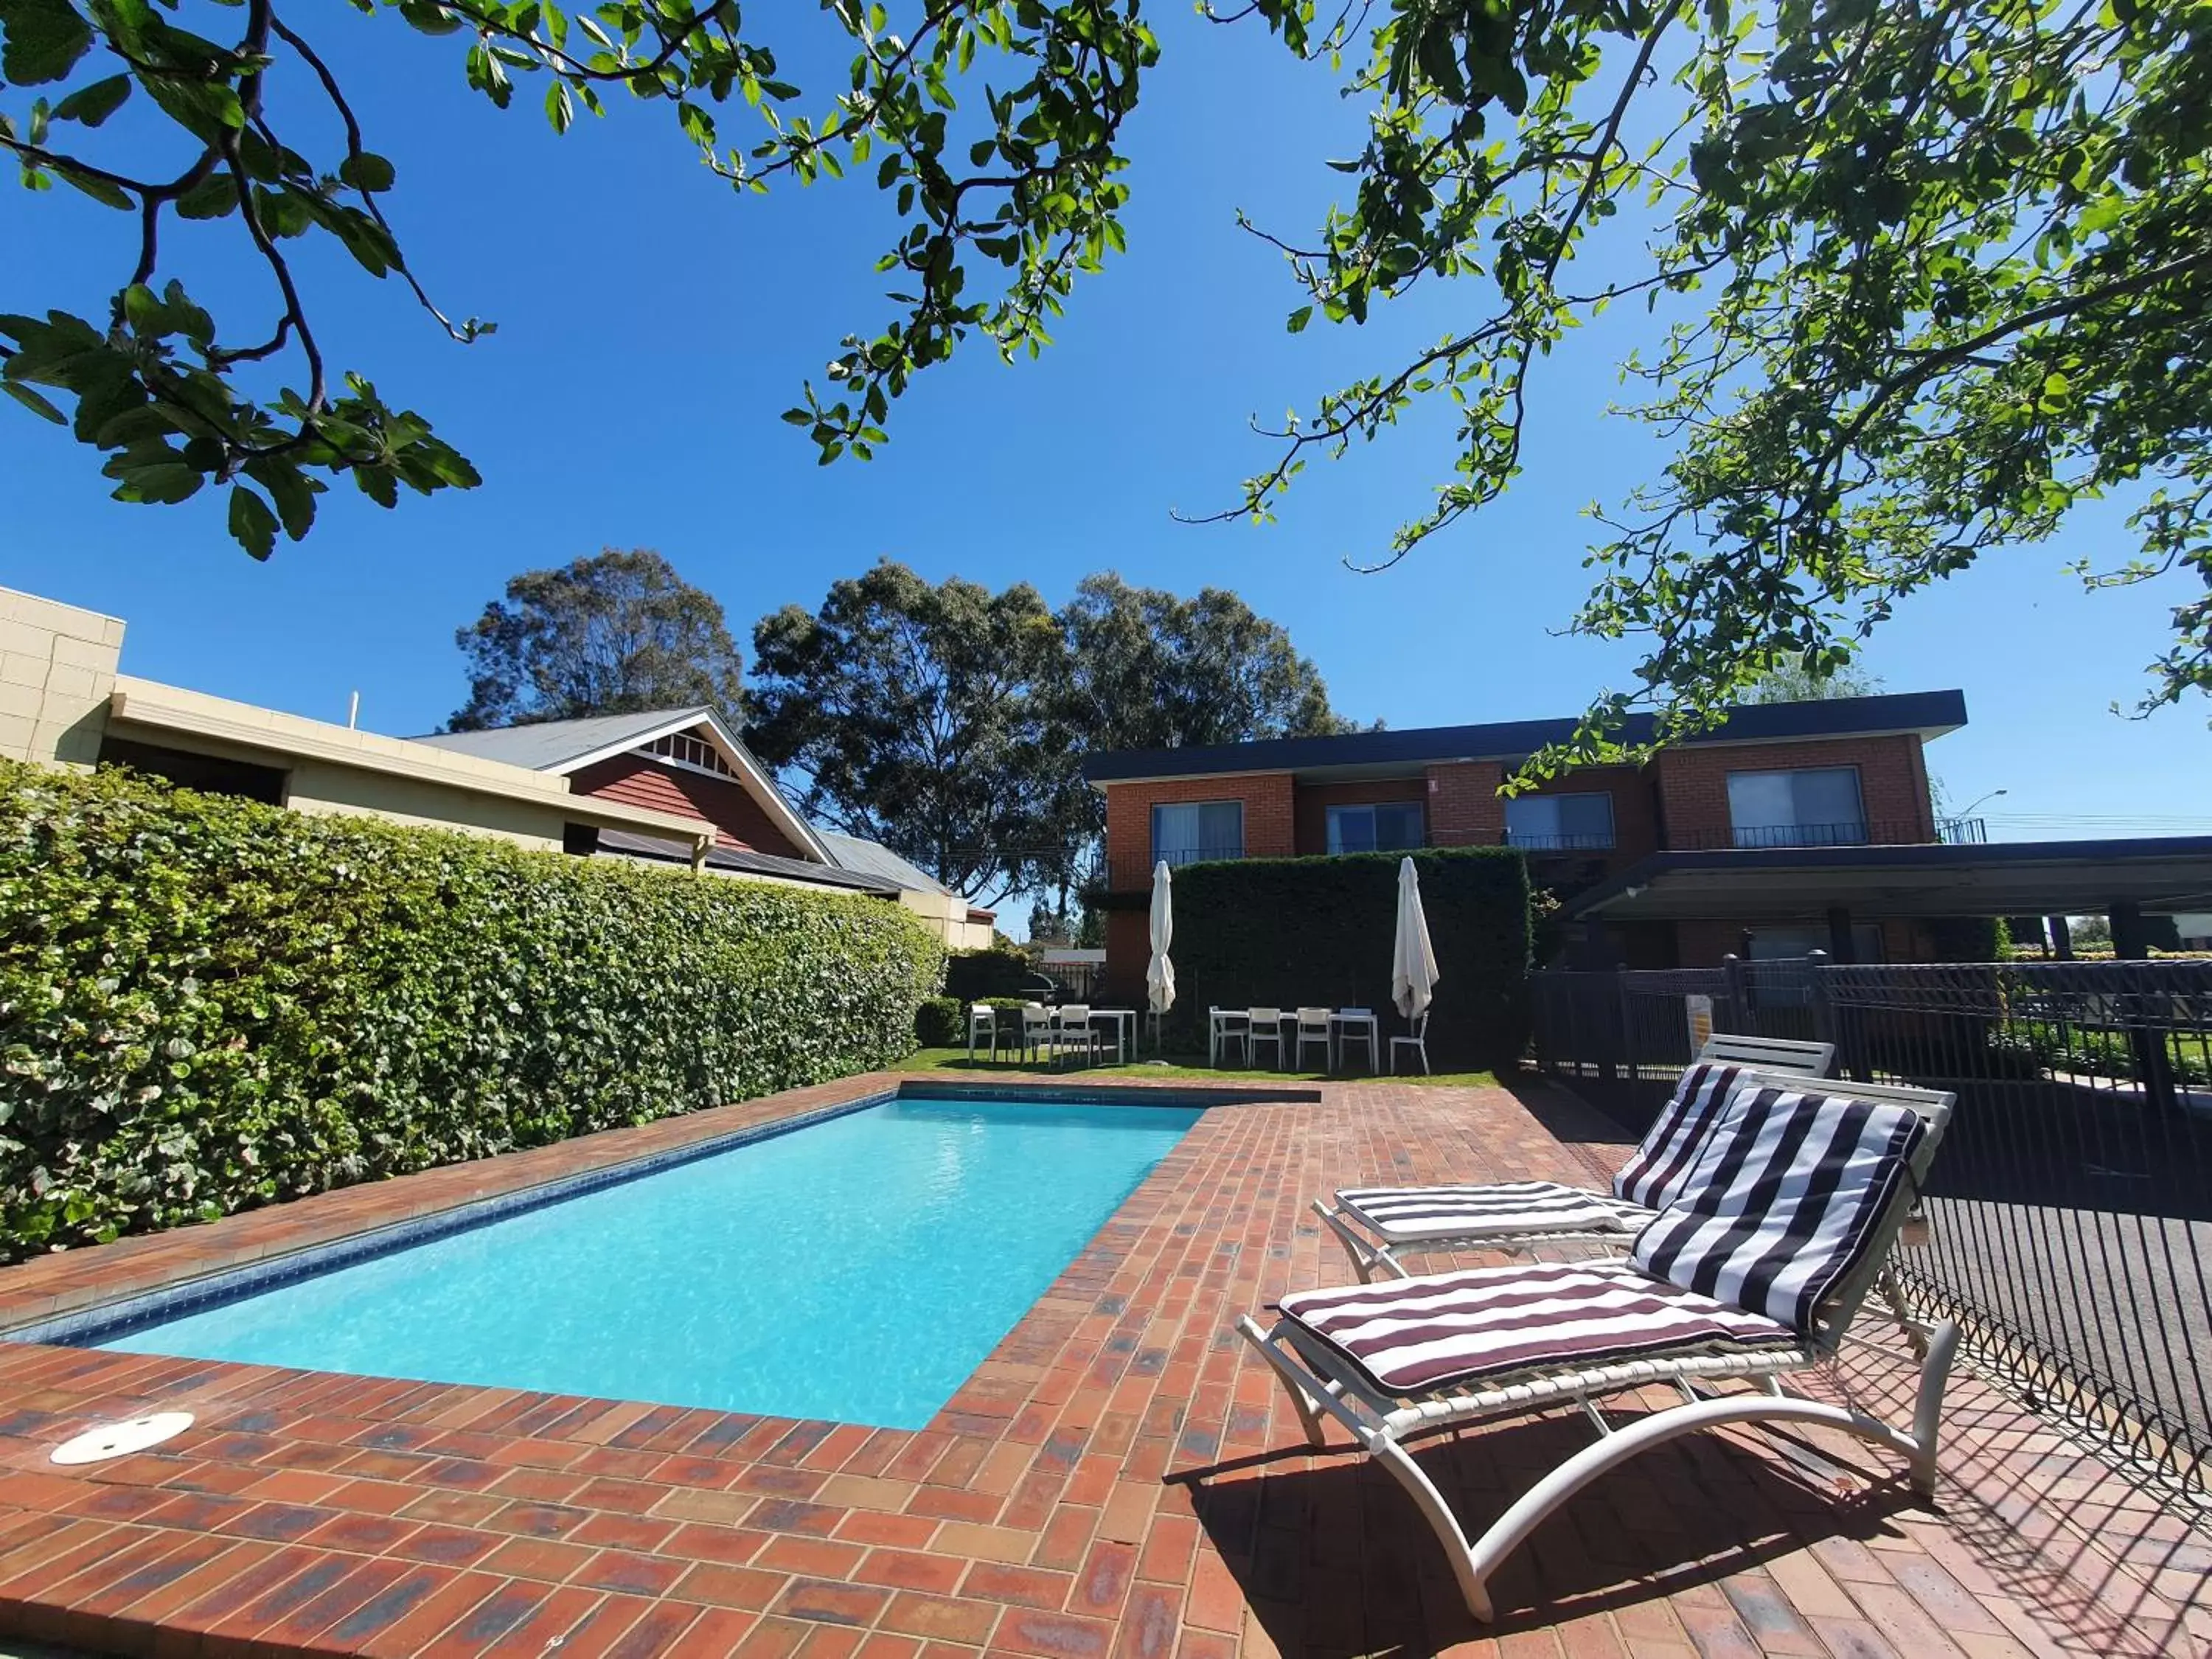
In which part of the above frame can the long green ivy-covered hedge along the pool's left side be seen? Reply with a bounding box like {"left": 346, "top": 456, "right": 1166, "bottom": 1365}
{"left": 0, "top": 763, "right": 945, "bottom": 1259}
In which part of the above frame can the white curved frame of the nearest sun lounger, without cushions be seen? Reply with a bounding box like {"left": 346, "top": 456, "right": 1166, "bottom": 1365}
{"left": 1237, "top": 1084, "right": 1958, "bottom": 1624}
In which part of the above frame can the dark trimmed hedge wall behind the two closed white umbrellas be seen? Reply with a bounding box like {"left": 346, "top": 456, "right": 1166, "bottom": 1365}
{"left": 1170, "top": 847, "right": 1528, "bottom": 1071}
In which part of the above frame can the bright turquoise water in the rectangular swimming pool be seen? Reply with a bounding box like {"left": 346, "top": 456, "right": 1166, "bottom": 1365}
{"left": 100, "top": 1099, "right": 1199, "bottom": 1429}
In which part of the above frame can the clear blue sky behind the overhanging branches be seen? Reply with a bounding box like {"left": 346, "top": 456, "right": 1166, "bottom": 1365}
{"left": 0, "top": 7, "right": 2212, "bottom": 838}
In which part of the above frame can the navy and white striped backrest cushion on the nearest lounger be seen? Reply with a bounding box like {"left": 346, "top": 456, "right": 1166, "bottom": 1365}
{"left": 1628, "top": 1086, "right": 1927, "bottom": 1332}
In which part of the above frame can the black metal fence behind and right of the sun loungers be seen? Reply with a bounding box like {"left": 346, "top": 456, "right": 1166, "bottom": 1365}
{"left": 1533, "top": 956, "right": 2212, "bottom": 1502}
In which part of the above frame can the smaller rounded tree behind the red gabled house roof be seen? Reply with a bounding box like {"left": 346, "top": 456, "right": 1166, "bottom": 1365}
{"left": 449, "top": 549, "right": 741, "bottom": 732}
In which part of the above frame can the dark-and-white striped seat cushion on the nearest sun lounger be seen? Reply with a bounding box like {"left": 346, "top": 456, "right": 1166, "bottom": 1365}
{"left": 1279, "top": 1261, "right": 1798, "bottom": 1394}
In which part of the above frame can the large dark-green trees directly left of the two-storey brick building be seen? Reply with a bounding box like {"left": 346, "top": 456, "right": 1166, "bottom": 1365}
{"left": 748, "top": 560, "right": 1349, "bottom": 925}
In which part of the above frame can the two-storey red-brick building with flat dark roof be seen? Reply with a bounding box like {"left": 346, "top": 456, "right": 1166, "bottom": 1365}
{"left": 1084, "top": 690, "right": 1980, "bottom": 991}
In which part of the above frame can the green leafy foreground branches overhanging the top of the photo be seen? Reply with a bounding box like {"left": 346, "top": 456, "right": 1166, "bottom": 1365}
{"left": 0, "top": 0, "right": 2212, "bottom": 748}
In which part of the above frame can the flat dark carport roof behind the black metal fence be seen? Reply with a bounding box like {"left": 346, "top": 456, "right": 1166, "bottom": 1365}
{"left": 1566, "top": 836, "right": 2212, "bottom": 922}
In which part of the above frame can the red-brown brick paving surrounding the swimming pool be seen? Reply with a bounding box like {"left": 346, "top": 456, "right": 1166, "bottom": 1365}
{"left": 0, "top": 1075, "right": 2212, "bottom": 1659}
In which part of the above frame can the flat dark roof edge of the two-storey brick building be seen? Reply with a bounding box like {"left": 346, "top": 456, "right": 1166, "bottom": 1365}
{"left": 1084, "top": 690, "right": 1966, "bottom": 785}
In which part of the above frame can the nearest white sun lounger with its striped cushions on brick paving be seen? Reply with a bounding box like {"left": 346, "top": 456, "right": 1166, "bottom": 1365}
{"left": 1237, "top": 1079, "right": 1958, "bottom": 1621}
